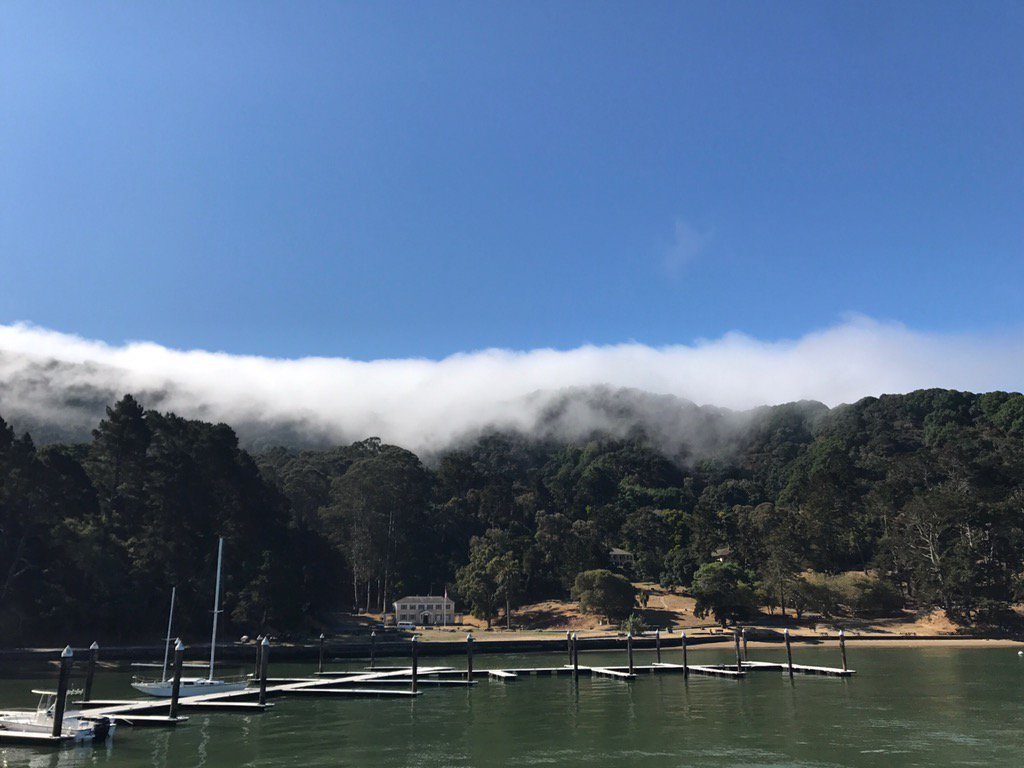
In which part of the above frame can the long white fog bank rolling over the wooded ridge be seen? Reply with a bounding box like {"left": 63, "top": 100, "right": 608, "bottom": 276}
{"left": 0, "top": 317, "right": 1024, "bottom": 453}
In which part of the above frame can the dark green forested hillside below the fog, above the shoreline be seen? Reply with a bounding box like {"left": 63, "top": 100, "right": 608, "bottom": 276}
{"left": 0, "top": 390, "right": 1024, "bottom": 644}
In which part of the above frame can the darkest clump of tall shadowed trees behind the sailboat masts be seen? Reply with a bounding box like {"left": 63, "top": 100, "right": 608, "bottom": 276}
{"left": 0, "top": 397, "right": 302, "bottom": 642}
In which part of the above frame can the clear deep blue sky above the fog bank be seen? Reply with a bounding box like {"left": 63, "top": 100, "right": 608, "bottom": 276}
{"left": 0, "top": 2, "right": 1024, "bottom": 358}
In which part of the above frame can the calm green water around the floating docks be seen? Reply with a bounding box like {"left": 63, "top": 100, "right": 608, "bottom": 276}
{"left": 0, "top": 646, "right": 1024, "bottom": 768}
